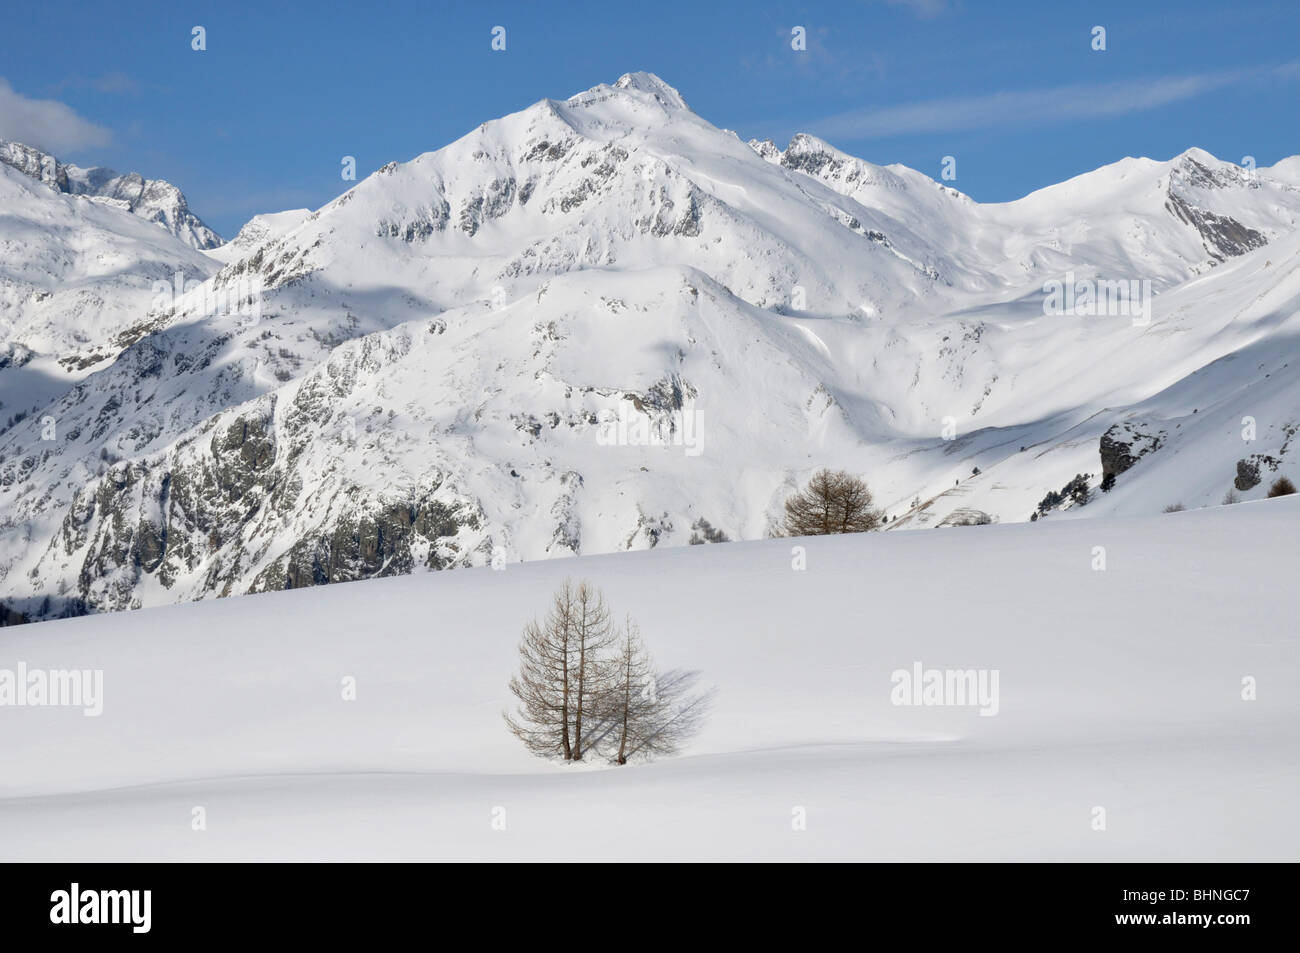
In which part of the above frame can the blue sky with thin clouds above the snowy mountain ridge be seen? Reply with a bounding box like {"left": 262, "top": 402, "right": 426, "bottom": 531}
{"left": 0, "top": 0, "right": 1300, "bottom": 237}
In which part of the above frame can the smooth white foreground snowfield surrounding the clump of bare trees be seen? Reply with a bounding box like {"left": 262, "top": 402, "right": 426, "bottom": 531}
{"left": 0, "top": 499, "right": 1300, "bottom": 862}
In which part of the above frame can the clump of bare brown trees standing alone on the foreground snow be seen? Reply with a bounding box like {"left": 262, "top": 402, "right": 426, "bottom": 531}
{"left": 504, "top": 581, "right": 709, "bottom": 764}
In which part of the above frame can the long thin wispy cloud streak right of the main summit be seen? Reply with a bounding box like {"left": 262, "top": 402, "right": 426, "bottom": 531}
{"left": 807, "top": 62, "right": 1300, "bottom": 139}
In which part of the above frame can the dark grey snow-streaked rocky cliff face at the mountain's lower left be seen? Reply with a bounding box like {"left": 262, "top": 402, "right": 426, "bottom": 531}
{"left": 35, "top": 379, "right": 481, "bottom": 610}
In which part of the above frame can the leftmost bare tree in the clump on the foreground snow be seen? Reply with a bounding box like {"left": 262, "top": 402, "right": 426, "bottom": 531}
{"left": 504, "top": 581, "right": 575, "bottom": 761}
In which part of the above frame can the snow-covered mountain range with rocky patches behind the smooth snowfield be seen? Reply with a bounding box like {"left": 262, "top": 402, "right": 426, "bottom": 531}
{"left": 0, "top": 73, "right": 1300, "bottom": 618}
